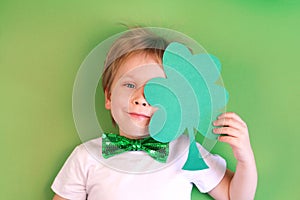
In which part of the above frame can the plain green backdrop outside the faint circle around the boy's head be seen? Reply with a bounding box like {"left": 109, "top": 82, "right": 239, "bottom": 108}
{"left": 0, "top": 0, "right": 300, "bottom": 200}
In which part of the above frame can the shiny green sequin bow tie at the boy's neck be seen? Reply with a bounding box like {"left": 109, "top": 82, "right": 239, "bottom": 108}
{"left": 102, "top": 133, "right": 169, "bottom": 163}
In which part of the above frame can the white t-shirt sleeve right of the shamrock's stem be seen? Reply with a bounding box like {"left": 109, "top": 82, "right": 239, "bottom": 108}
{"left": 183, "top": 144, "right": 226, "bottom": 193}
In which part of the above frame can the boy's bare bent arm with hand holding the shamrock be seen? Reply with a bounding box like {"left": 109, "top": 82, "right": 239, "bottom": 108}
{"left": 209, "top": 112, "right": 257, "bottom": 200}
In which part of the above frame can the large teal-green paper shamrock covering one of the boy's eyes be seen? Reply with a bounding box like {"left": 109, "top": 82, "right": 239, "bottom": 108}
{"left": 144, "top": 42, "right": 228, "bottom": 170}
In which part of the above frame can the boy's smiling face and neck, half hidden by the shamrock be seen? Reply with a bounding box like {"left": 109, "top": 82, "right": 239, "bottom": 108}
{"left": 105, "top": 54, "right": 165, "bottom": 138}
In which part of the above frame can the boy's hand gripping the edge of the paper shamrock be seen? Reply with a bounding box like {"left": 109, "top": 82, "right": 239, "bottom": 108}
{"left": 213, "top": 112, "right": 254, "bottom": 164}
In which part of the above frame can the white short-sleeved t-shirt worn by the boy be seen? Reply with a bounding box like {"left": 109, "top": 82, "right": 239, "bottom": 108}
{"left": 51, "top": 136, "right": 226, "bottom": 200}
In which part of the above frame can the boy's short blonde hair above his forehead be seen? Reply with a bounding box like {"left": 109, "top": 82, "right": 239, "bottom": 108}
{"left": 102, "top": 28, "right": 168, "bottom": 94}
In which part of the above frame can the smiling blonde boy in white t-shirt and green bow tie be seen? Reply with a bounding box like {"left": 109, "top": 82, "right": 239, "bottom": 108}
{"left": 52, "top": 28, "right": 257, "bottom": 200}
